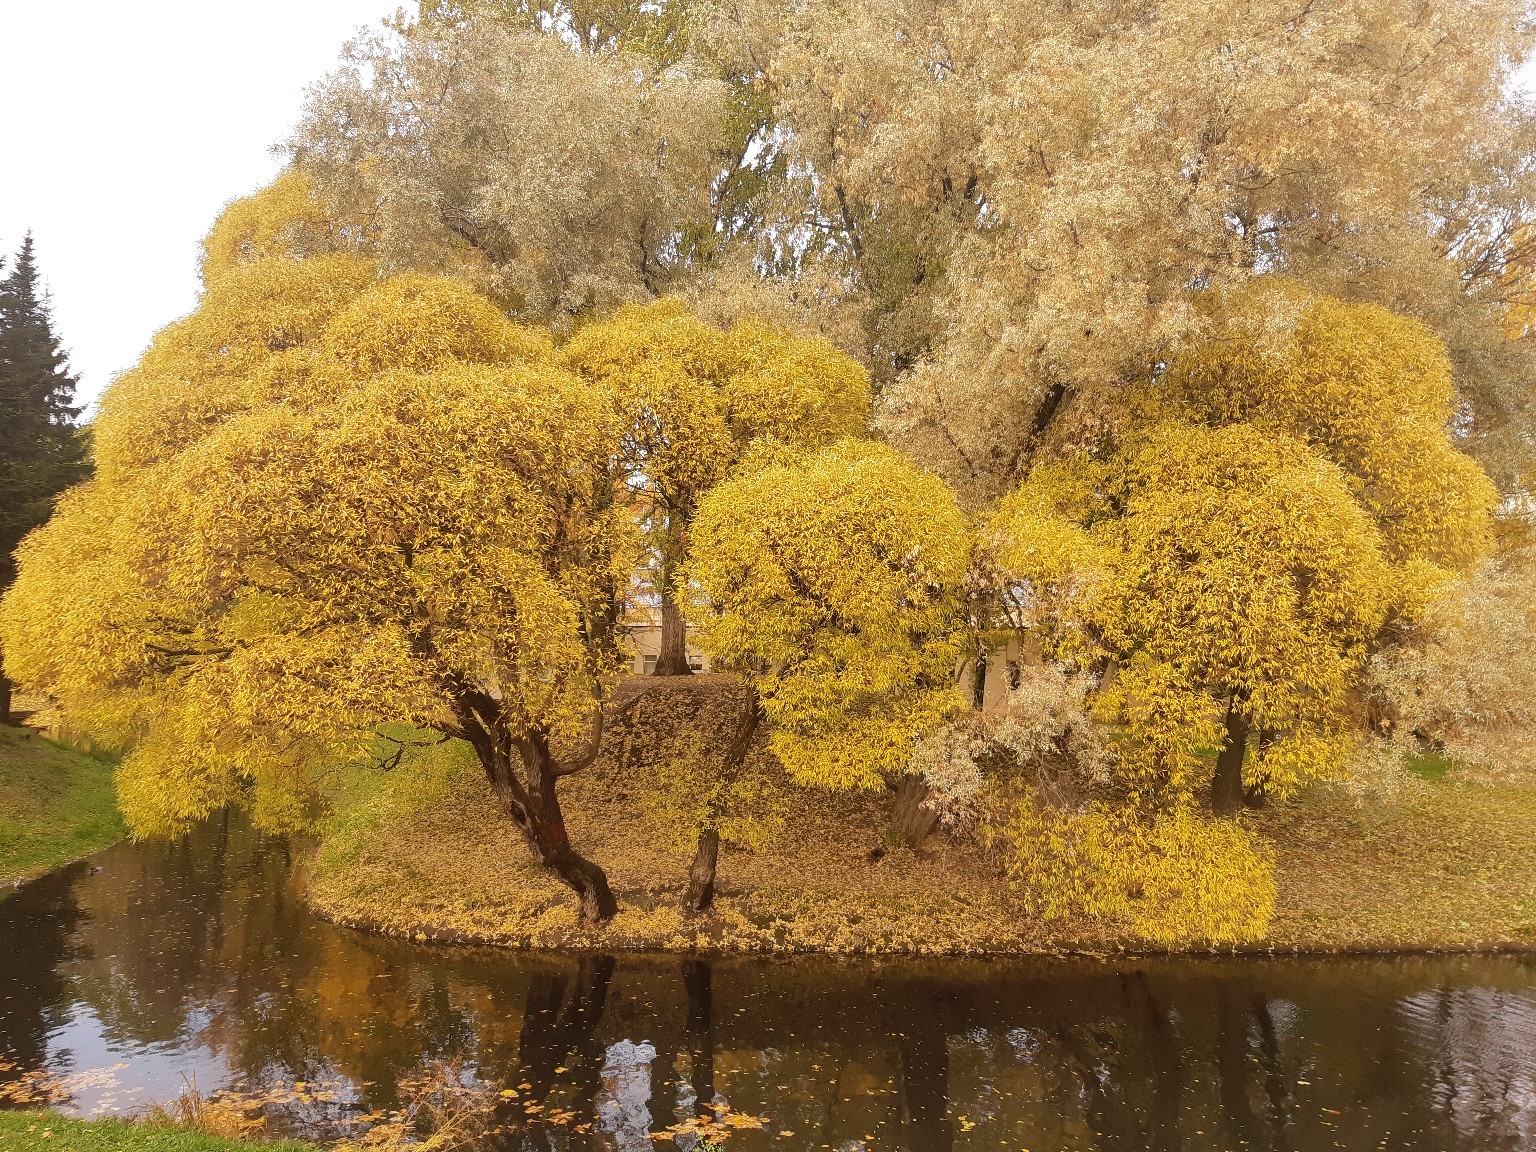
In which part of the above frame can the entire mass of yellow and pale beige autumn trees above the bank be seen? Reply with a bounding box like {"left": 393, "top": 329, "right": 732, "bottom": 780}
{"left": 0, "top": 0, "right": 1536, "bottom": 945}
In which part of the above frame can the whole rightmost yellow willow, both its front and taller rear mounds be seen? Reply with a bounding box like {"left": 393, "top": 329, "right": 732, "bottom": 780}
{"left": 997, "top": 287, "right": 1496, "bottom": 813}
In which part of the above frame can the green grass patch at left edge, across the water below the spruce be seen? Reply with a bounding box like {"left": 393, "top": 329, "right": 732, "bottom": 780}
{"left": 0, "top": 725, "right": 124, "bottom": 886}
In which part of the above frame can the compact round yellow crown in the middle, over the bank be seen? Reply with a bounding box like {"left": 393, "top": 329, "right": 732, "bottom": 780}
{"left": 688, "top": 441, "right": 969, "bottom": 788}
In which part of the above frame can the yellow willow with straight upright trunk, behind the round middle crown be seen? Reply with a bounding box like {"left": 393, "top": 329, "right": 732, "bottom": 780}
{"left": 561, "top": 300, "right": 869, "bottom": 676}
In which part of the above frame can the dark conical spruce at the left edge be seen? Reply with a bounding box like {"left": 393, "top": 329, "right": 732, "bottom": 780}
{"left": 0, "top": 233, "right": 89, "bottom": 722}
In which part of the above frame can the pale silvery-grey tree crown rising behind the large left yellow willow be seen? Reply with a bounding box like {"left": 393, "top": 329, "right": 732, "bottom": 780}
{"left": 290, "top": 12, "right": 727, "bottom": 327}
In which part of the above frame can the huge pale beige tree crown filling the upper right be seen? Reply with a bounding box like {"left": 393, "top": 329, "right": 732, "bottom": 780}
{"left": 694, "top": 0, "right": 1536, "bottom": 495}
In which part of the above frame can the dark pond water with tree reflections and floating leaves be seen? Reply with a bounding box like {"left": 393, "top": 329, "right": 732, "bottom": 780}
{"left": 0, "top": 822, "right": 1536, "bottom": 1152}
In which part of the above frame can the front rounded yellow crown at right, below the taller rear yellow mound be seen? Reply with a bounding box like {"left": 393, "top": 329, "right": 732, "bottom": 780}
{"left": 989, "top": 424, "right": 1399, "bottom": 796}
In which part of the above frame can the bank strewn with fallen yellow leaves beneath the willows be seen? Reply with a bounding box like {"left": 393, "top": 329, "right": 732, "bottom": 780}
{"left": 310, "top": 675, "right": 1536, "bottom": 954}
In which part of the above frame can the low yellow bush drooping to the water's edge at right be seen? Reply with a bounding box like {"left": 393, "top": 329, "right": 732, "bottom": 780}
{"left": 997, "top": 799, "right": 1275, "bottom": 946}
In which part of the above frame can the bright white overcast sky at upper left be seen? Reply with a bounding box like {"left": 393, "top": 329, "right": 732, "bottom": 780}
{"left": 0, "top": 0, "right": 415, "bottom": 411}
